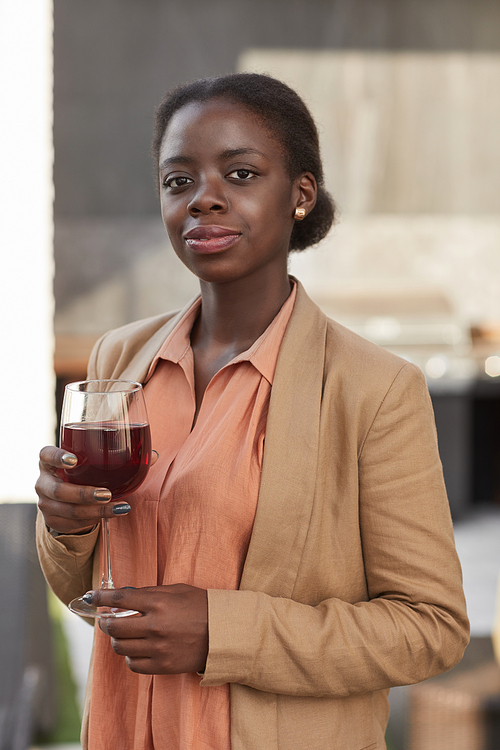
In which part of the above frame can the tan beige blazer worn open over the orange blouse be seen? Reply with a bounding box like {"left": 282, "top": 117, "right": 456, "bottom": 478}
{"left": 38, "top": 284, "right": 468, "bottom": 750}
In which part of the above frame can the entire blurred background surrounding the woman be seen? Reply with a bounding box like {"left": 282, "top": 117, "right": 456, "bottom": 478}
{"left": 0, "top": 0, "right": 500, "bottom": 750}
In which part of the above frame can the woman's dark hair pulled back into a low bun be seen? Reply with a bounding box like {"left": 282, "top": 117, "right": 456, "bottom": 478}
{"left": 151, "top": 73, "right": 335, "bottom": 251}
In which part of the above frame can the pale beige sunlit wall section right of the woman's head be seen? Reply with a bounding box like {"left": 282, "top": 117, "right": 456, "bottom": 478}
{"left": 244, "top": 49, "right": 500, "bottom": 328}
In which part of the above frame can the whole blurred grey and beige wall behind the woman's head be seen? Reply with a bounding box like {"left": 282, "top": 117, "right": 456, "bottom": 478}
{"left": 54, "top": 0, "right": 500, "bottom": 334}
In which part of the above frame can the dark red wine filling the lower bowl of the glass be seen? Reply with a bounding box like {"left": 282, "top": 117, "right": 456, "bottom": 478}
{"left": 61, "top": 422, "right": 151, "bottom": 500}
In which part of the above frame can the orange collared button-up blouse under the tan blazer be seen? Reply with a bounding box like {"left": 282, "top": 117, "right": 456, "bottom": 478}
{"left": 89, "top": 285, "right": 296, "bottom": 750}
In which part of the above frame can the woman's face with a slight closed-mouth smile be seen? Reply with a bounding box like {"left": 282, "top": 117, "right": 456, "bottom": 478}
{"left": 159, "top": 99, "right": 301, "bottom": 282}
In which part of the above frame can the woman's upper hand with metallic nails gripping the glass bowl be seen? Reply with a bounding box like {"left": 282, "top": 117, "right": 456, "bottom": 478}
{"left": 35, "top": 445, "right": 130, "bottom": 534}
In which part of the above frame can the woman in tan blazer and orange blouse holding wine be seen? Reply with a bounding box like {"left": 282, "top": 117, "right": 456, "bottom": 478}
{"left": 37, "top": 74, "right": 468, "bottom": 750}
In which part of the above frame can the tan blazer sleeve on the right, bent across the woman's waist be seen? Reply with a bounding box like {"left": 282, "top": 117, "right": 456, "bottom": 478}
{"left": 202, "top": 366, "right": 468, "bottom": 697}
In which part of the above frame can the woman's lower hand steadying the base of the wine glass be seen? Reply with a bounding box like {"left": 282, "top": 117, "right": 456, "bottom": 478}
{"left": 89, "top": 583, "right": 208, "bottom": 674}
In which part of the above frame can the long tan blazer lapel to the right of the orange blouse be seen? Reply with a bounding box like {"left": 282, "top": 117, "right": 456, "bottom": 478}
{"left": 240, "top": 282, "right": 327, "bottom": 597}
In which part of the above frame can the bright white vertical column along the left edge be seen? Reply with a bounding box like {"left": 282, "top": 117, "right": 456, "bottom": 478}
{"left": 0, "top": 0, "right": 55, "bottom": 502}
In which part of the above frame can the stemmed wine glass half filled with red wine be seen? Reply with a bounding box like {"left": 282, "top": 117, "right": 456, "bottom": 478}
{"left": 60, "top": 380, "right": 151, "bottom": 618}
